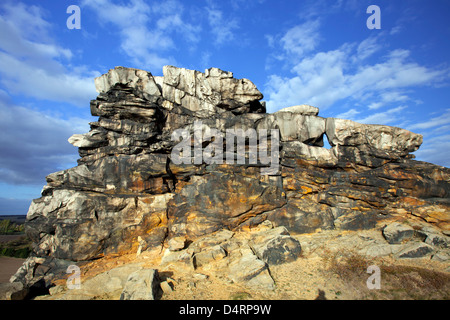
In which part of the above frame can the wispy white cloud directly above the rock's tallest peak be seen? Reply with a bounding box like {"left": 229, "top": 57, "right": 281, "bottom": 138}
{"left": 82, "top": 0, "right": 200, "bottom": 71}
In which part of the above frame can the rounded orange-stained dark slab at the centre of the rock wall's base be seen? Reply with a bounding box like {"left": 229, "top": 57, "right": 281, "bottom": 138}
{"left": 168, "top": 171, "right": 285, "bottom": 239}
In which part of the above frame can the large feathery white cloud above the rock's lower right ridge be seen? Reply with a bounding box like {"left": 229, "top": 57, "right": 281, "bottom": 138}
{"left": 266, "top": 29, "right": 448, "bottom": 112}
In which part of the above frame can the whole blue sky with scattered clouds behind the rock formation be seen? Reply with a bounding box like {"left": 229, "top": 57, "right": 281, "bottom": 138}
{"left": 0, "top": 0, "right": 450, "bottom": 214}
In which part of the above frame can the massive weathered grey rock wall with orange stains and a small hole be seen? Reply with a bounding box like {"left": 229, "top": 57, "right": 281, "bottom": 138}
{"left": 13, "top": 66, "right": 450, "bottom": 292}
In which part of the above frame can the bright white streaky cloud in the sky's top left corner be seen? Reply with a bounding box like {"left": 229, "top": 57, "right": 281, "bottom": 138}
{"left": 0, "top": 3, "right": 99, "bottom": 106}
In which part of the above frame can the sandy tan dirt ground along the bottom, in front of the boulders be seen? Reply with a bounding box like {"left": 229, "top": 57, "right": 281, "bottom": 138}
{"left": 55, "top": 228, "right": 450, "bottom": 300}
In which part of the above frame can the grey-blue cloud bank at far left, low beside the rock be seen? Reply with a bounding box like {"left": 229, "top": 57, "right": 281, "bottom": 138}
{"left": 0, "top": 97, "right": 89, "bottom": 185}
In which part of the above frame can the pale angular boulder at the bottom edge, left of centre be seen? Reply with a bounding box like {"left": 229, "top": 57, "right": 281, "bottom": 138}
{"left": 120, "top": 269, "right": 159, "bottom": 300}
